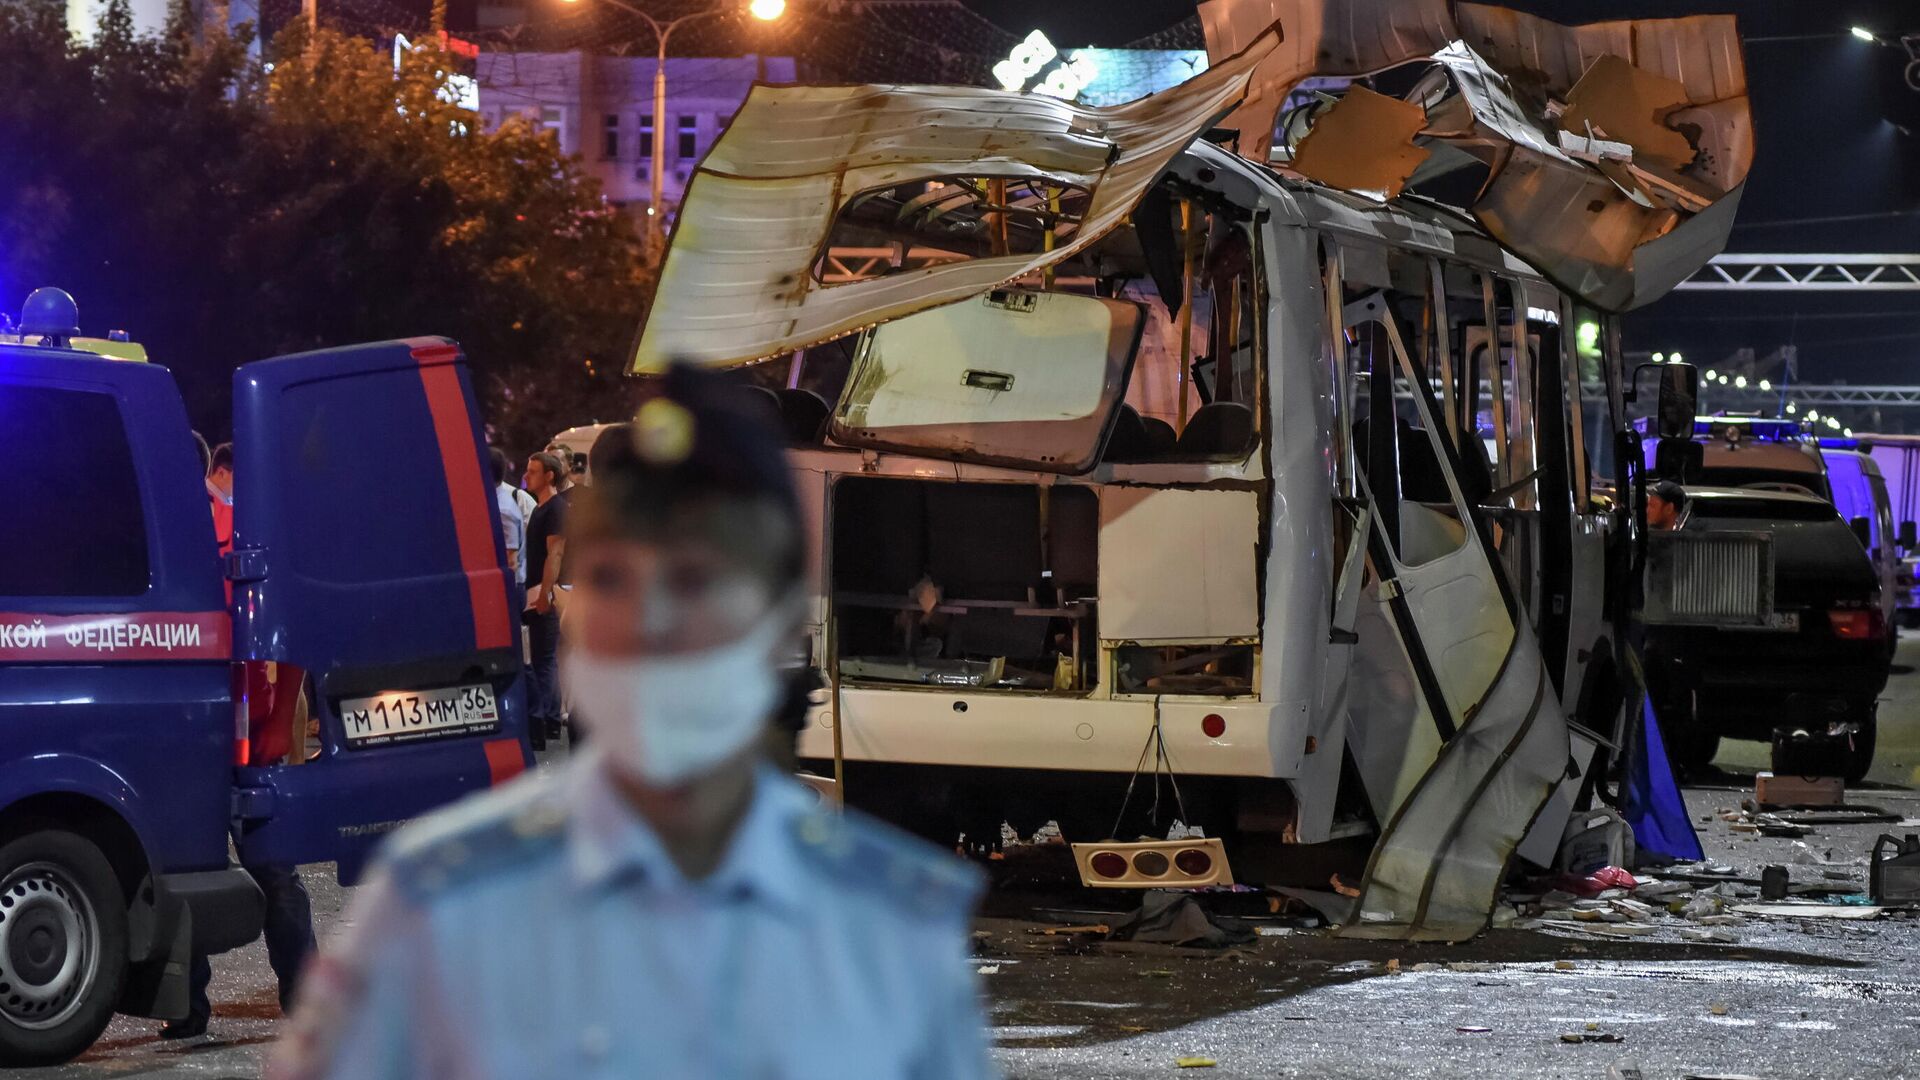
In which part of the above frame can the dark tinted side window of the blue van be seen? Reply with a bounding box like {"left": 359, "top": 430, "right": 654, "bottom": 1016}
{"left": 0, "top": 384, "right": 148, "bottom": 596}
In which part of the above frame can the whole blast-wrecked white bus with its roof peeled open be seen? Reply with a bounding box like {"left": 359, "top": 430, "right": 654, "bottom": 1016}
{"left": 636, "top": 6, "right": 1738, "bottom": 938}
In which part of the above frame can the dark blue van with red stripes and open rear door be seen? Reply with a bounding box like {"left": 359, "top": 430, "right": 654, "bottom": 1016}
{"left": 0, "top": 294, "right": 532, "bottom": 1065}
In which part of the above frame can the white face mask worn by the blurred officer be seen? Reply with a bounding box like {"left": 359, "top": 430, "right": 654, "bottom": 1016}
{"left": 561, "top": 605, "right": 791, "bottom": 788}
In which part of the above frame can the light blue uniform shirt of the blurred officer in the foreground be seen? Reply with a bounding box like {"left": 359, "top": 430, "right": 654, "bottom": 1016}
{"left": 269, "top": 751, "right": 993, "bottom": 1080}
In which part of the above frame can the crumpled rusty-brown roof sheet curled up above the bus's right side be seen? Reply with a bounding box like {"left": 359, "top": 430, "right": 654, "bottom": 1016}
{"left": 1200, "top": 0, "right": 1753, "bottom": 311}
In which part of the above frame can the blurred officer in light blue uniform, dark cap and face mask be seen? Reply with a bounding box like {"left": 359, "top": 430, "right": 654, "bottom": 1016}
{"left": 273, "top": 367, "right": 993, "bottom": 1080}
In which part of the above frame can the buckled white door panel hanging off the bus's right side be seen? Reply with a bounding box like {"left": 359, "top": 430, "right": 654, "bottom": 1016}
{"left": 1346, "top": 294, "right": 1569, "bottom": 940}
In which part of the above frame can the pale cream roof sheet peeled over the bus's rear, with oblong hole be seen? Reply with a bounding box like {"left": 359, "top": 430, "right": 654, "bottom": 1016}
{"left": 630, "top": 29, "right": 1281, "bottom": 373}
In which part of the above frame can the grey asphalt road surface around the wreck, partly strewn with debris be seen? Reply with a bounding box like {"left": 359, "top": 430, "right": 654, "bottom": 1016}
{"left": 17, "top": 638, "right": 1920, "bottom": 1080}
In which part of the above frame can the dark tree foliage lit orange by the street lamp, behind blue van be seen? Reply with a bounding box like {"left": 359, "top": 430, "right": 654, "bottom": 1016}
{"left": 0, "top": 0, "right": 649, "bottom": 450}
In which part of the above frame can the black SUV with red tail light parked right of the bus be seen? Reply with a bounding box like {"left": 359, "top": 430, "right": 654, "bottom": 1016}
{"left": 1644, "top": 486, "right": 1891, "bottom": 782}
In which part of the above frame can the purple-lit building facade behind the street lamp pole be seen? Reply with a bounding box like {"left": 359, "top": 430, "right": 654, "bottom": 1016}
{"left": 474, "top": 50, "right": 795, "bottom": 215}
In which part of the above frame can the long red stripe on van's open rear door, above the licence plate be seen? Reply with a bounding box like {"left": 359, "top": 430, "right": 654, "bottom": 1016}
{"left": 413, "top": 344, "right": 515, "bottom": 650}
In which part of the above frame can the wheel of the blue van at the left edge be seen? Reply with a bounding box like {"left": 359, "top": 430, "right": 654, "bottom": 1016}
{"left": 0, "top": 828, "right": 127, "bottom": 1067}
